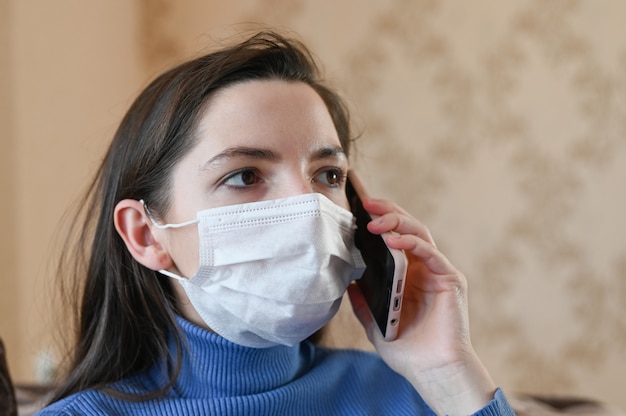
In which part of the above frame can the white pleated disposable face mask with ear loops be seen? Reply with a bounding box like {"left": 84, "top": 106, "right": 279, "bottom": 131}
{"left": 143, "top": 194, "right": 365, "bottom": 348}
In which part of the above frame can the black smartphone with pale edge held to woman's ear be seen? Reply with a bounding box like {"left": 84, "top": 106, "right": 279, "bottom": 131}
{"left": 346, "top": 171, "right": 408, "bottom": 341}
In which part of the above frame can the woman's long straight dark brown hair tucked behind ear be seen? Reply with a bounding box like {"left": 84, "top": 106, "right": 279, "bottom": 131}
{"left": 52, "top": 32, "right": 351, "bottom": 401}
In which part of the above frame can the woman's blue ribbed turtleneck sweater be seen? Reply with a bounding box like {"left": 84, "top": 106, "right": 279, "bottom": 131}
{"left": 39, "top": 319, "right": 514, "bottom": 416}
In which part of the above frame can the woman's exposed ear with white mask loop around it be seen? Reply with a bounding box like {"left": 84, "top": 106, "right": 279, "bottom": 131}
{"left": 113, "top": 199, "right": 173, "bottom": 270}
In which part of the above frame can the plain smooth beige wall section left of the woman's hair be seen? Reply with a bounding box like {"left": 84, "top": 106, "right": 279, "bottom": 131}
{"left": 0, "top": 0, "right": 144, "bottom": 380}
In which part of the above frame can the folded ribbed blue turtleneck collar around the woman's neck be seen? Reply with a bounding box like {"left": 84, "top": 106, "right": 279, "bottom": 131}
{"left": 162, "top": 318, "right": 314, "bottom": 398}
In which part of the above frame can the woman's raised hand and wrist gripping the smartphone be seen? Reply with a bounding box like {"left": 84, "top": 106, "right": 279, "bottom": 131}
{"left": 349, "top": 198, "right": 496, "bottom": 414}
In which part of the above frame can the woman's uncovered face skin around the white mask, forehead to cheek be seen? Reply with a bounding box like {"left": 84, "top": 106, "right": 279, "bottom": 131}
{"left": 157, "top": 80, "right": 348, "bottom": 278}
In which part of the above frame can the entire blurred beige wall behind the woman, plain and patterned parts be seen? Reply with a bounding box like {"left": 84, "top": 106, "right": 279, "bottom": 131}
{"left": 0, "top": 0, "right": 626, "bottom": 409}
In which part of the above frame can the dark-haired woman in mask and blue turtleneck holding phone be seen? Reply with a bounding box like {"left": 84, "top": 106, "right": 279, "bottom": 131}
{"left": 41, "top": 32, "right": 513, "bottom": 415}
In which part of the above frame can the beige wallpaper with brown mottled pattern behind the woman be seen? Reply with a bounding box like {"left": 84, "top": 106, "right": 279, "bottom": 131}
{"left": 0, "top": 0, "right": 626, "bottom": 409}
